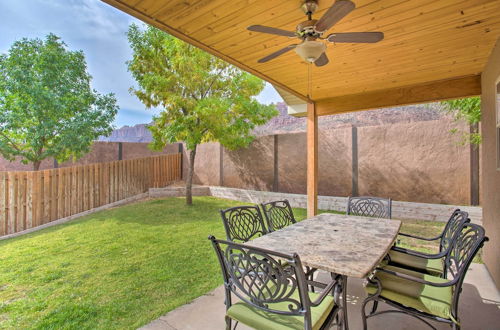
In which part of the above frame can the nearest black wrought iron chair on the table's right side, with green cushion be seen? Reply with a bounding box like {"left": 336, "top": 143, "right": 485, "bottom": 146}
{"left": 361, "top": 224, "right": 488, "bottom": 329}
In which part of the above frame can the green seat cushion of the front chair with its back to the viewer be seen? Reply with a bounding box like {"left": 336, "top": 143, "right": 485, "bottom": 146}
{"left": 226, "top": 290, "right": 335, "bottom": 330}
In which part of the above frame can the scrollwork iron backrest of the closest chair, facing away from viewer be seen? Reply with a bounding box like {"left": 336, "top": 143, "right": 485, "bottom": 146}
{"left": 209, "top": 236, "right": 310, "bottom": 322}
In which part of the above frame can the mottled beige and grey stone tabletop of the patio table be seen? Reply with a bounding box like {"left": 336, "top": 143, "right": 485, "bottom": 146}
{"left": 245, "top": 213, "right": 401, "bottom": 278}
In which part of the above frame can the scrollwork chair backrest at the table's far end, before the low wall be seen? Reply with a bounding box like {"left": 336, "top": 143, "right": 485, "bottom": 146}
{"left": 347, "top": 197, "right": 392, "bottom": 219}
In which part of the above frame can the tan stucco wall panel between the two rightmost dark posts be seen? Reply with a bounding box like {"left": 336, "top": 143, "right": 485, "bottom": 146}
{"left": 358, "top": 120, "right": 470, "bottom": 204}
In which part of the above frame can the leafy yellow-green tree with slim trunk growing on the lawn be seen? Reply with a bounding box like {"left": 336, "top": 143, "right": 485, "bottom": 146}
{"left": 128, "top": 25, "right": 277, "bottom": 205}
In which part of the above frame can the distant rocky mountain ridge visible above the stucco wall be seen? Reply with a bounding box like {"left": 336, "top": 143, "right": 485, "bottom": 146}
{"left": 99, "top": 102, "right": 446, "bottom": 142}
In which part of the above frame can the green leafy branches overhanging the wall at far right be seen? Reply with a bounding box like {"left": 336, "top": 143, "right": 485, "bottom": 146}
{"left": 441, "top": 97, "right": 481, "bottom": 145}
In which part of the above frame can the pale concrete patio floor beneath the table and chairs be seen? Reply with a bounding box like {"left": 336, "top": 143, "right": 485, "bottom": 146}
{"left": 141, "top": 264, "right": 500, "bottom": 330}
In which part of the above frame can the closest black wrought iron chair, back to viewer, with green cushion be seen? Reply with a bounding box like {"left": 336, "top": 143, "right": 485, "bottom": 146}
{"left": 209, "top": 236, "right": 338, "bottom": 329}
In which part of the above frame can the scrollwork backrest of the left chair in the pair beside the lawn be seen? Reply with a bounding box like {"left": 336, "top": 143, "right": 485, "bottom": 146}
{"left": 220, "top": 205, "right": 267, "bottom": 242}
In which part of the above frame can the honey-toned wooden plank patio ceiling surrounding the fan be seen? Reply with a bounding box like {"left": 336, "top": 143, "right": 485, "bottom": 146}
{"left": 103, "top": 0, "right": 500, "bottom": 114}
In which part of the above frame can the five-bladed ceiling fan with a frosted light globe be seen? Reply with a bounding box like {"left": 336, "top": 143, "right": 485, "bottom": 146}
{"left": 247, "top": 0, "right": 384, "bottom": 66}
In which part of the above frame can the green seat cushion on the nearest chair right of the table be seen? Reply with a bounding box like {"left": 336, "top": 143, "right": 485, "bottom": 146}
{"left": 365, "top": 266, "right": 453, "bottom": 319}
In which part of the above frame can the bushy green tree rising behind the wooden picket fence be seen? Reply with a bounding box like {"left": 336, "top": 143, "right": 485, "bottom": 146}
{"left": 0, "top": 34, "right": 118, "bottom": 170}
